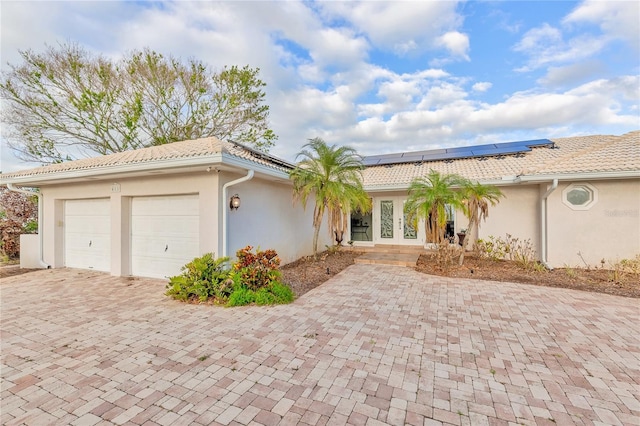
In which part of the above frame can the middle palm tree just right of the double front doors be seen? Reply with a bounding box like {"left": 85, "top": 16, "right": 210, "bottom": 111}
{"left": 404, "top": 170, "right": 466, "bottom": 244}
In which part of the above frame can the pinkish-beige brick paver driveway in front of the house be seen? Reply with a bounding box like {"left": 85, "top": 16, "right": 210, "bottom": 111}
{"left": 0, "top": 265, "right": 640, "bottom": 425}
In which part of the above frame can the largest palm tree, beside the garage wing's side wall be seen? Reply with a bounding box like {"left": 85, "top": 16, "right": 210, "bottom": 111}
{"left": 289, "top": 138, "right": 371, "bottom": 256}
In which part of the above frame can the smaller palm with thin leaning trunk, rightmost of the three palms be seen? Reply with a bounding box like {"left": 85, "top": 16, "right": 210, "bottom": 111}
{"left": 458, "top": 181, "right": 504, "bottom": 265}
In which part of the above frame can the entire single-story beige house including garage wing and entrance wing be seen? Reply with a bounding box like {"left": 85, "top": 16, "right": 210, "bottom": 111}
{"left": 0, "top": 131, "right": 640, "bottom": 277}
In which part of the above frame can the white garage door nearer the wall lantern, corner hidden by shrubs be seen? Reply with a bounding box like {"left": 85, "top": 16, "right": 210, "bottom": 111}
{"left": 131, "top": 195, "right": 200, "bottom": 278}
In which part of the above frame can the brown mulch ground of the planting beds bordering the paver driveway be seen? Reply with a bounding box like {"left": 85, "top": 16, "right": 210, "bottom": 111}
{"left": 0, "top": 250, "right": 640, "bottom": 298}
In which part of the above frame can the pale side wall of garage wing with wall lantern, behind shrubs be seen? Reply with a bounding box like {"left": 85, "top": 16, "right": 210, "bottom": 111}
{"left": 224, "top": 173, "right": 331, "bottom": 264}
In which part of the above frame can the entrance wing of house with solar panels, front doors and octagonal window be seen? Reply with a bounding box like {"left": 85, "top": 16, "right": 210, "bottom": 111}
{"left": 358, "top": 131, "right": 640, "bottom": 267}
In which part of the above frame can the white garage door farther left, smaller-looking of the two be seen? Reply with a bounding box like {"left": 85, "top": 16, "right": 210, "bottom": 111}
{"left": 64, "top": 198, "right": 111, "bottom": 272}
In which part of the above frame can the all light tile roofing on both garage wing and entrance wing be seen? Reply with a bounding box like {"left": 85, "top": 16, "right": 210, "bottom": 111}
{"left": 0, "top": 131, "right": 640, "bottom": 188}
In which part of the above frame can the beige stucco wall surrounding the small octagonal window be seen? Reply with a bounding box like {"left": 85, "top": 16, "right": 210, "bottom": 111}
{"left": 547, "top": 179, "right": 640, "bottom": 268}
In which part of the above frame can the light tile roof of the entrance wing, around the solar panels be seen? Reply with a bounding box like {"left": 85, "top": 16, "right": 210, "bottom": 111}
{"left": 363, "top": 131, "right": 640, "bottom": 188}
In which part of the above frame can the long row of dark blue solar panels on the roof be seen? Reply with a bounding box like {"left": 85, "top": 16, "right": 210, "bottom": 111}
{"left": 363, "top": 139, "right": 554, "bottom": 166}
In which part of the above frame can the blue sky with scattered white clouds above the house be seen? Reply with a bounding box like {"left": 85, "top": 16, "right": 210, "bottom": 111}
{"left": 0, "top": 0, "right": 640, "bottom": 172}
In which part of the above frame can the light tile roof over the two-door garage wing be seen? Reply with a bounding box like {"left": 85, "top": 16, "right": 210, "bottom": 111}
{"left": 0, "top": 137, "right": 289, "bottom": 180}
